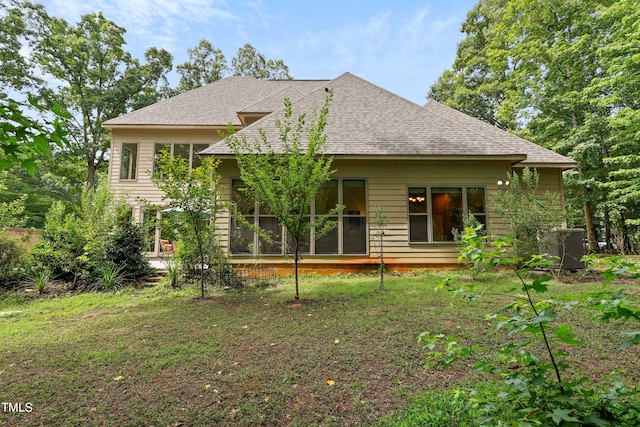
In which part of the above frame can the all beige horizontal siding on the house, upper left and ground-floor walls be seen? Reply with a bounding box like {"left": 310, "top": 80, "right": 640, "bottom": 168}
{"left": 109, "top": 140, "right": 562, "bottom": 267}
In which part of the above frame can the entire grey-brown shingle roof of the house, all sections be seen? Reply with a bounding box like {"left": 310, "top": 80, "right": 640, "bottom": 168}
{"left": 104, "top": 73, "right": 575, "bottom": 168}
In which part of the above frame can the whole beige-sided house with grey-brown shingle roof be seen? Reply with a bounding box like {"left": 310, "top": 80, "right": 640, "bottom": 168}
{"left": 104, "top": 73, "right": 576, "bottom": 270}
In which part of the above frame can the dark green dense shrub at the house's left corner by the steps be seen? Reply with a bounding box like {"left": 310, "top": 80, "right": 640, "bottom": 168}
{"left": 105, "top": 223, "right": 153, "bottom": 283}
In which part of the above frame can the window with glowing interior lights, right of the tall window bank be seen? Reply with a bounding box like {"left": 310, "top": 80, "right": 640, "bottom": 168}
{"left": 407, "top": 186, "right": 487, "bottom": 243}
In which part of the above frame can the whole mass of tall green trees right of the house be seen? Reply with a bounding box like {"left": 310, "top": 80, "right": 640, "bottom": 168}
{"left": 429, "top": 0, "right": 640, "bottom": 253}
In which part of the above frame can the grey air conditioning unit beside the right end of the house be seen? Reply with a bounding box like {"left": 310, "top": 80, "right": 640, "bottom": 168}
{"left": 541, "top": 228, "right": 586, "bottom": 270}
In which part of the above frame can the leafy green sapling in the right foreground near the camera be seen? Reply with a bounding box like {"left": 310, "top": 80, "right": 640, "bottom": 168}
{"left": 419, "top": 227, "right": 640, "bottom": 426}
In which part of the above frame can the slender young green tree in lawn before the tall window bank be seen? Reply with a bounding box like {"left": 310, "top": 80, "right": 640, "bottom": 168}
{"left": 227, "top": 93, "right": 343, "bottom": 299}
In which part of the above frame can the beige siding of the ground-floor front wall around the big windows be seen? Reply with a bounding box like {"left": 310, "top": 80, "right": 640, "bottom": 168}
{"left": 218, "top": 159, "right": 528, "bottom": 264}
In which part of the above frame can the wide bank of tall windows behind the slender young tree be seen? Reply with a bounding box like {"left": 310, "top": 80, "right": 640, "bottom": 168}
{"left": 229, "top": 179, "right": 368, "bottom": 255}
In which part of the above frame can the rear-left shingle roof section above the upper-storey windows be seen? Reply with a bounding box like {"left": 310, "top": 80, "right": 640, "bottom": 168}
{"left": 104, "top": 76, "right": 326, "bottom": 129}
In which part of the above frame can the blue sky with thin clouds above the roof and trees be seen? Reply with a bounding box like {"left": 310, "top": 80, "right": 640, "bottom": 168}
{"left": 35, "top": 0, "right": 477, "bottom": 104}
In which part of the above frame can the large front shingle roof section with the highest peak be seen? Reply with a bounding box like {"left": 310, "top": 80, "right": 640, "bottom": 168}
{"left": 203, "top": 73, "right": 574, "bottom": 166}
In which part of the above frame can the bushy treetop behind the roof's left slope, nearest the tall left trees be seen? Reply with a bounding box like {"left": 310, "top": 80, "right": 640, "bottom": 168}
{"left": 176, "top": 39, "right": 229, "bottom": 93}
